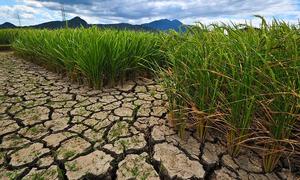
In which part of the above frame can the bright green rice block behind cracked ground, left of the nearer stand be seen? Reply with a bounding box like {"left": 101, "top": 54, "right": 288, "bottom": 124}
{"left": 13, "top": 28, "right": 162, "bottom": 88}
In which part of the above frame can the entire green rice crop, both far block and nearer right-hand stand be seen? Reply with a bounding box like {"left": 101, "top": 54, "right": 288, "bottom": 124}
{"left": 0, "top": 19, "right": 300, "bottom": 178}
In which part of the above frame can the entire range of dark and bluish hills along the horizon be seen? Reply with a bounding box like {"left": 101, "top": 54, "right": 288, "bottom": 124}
{"left": 0, "top": 16, "right": 183, "bottom": 31}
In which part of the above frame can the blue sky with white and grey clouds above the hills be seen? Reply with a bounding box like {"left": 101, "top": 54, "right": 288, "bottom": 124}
{"left": 0, "top": 0, "right": 300, "bottom": 26}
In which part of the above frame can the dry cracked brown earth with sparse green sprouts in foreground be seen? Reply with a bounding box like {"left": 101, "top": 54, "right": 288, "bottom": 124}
{"left": 0, "top": 52, "right": 297, "bottom": 180}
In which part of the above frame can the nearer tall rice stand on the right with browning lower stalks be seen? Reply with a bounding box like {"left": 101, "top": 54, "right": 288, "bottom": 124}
{"left": 159, "top": 19, "right": 300, "bottom": 172}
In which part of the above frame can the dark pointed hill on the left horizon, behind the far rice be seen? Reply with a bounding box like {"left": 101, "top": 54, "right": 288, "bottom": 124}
{"left": 30, "top": 16, "right": 89, "bottom": 29}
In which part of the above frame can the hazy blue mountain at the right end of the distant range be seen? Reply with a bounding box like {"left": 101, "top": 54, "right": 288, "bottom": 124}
{"left": 142, "top": 19, "right": 183, "bottom": 31}
